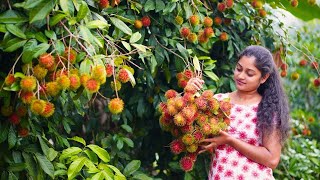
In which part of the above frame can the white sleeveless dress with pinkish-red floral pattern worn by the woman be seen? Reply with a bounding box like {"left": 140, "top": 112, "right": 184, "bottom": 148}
{"left": 208, "top": 93, "right": 274, "bottom": 180}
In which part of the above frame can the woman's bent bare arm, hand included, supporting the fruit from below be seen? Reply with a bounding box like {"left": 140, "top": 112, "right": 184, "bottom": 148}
{"left": 200, "top": 131, "right": 282, "bottom": 169}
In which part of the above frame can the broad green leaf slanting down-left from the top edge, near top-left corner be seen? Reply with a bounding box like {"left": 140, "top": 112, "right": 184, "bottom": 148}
{"left": 29, "top": 0, "right": 55, "bottom": 23}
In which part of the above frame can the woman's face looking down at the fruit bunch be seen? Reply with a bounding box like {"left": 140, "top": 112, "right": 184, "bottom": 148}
{"left": 234, "top": 56, "right": 267, "bottom": 91}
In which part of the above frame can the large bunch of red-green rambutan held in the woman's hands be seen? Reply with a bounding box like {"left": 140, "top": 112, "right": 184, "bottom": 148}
{"left": 159, "top": 80, "right": 231, "bottom": 171}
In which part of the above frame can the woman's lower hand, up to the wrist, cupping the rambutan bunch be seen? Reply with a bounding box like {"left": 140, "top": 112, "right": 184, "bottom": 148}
{"left": 199, "top": 130, "right": 231, "bottom": 154}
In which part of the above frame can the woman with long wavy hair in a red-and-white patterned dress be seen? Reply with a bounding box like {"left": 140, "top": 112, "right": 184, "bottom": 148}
{"left": 188, "top": 46, "right": 290, "bottom": 180}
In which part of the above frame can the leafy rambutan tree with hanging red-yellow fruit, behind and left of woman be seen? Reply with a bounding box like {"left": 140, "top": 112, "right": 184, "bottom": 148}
{"left": 0, "top": 0, "right": 319, "bottom": 179}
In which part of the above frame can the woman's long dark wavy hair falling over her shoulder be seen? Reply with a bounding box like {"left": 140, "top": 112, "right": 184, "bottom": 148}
{"left": 239, "top": 46, "right": 290, "bottom": 144}
